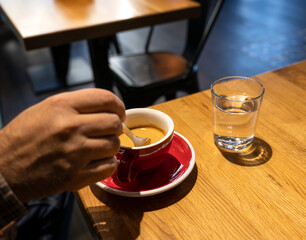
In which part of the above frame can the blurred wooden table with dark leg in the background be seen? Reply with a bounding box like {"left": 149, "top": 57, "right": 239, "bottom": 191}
{"left": 0, "top": 0, "right": 200, "bottom": 89}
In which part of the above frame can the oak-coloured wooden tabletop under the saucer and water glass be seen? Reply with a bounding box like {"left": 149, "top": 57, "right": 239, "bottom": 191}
{"left": 76, "top": 61, "right": 306, "bottom": 239}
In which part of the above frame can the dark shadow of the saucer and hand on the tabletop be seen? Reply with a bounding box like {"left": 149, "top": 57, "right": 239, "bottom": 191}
{"left": 87, "top": 165, "right": 198, "bottom": 239}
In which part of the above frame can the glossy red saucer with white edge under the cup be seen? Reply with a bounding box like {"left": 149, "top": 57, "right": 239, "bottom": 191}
{"left": 96, "top": 132, "right": 195, "bottom": 197}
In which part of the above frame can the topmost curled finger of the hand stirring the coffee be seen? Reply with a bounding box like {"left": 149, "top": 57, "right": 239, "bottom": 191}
{"left": 62, "top": 88, "right": 125, "bottom": 121}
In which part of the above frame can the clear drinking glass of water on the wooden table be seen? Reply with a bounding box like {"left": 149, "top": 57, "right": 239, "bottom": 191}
{"left": 211, "top": 76, "right": 265, "bottom": 151}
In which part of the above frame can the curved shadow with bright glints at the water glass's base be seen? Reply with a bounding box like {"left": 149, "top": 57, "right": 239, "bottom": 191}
{"left": 218, "top": 137, "right": 272, "bottom": 167}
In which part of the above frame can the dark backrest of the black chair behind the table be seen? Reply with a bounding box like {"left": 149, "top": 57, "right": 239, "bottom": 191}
{"left": 183, "top": 0, "right": 224, "bottom": 74}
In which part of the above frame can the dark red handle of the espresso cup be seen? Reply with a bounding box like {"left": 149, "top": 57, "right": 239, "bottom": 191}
{"left": 116, "top": 149, "right": 139, "bottom": 183}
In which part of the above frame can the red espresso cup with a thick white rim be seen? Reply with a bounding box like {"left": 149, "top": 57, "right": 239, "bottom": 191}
{"left": 116, "top": 108, "right": 174, "bottom": 183}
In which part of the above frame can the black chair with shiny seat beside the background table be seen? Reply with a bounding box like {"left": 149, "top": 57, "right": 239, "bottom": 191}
{"left": 110, "top": 0, "right": 223, "bottom": 108}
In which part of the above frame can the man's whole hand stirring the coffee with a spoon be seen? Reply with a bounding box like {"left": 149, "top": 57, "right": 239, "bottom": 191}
{"left": 0, "top": 89, "right": 125, "bottom": 202}
